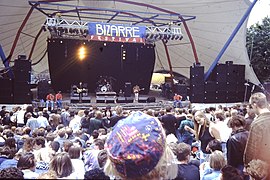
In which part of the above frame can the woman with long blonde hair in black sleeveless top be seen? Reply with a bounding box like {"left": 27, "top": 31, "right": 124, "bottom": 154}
{"left": 185, "top": 111, "right": 220, "bottom": 163}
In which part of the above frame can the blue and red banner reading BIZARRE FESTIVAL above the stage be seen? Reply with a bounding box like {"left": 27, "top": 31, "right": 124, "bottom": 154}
{"left": 87, "top": 22, "right": 146, "bottom": 43}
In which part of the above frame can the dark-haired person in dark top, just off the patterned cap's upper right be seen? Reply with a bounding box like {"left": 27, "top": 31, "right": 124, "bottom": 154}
{"left": 160, "top": 106, "right": 178, "bottom": 136}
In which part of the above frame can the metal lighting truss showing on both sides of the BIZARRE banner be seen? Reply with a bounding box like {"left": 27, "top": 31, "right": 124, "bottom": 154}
{"left": 42, "top": 17, "right": 183, "bottom": 43}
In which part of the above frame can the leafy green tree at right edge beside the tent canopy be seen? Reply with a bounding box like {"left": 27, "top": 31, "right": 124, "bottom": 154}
{"left": 246, "top": 17, "right": 270, "bottom": 83}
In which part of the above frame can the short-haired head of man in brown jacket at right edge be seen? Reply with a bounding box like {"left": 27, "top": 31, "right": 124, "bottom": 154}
{"left": 249, "top": 92, "right": 268, "bottom": 114}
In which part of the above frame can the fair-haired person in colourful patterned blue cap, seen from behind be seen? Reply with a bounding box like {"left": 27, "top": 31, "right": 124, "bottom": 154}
{"left": 104, "top": 111, "right": 177, "bottom": 179}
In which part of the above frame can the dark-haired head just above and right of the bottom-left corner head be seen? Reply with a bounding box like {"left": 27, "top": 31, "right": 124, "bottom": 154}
{"left": 17, "top": 153, "right": 36, "bottom": 171}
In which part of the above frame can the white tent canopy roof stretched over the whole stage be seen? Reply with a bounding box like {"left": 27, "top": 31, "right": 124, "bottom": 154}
{"left": 0, "top": 0, "right": 260, "bottom": 85}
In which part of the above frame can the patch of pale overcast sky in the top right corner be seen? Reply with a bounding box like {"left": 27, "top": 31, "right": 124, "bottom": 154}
{"left": 248, "top": 0, "right": 270, "bottom": 27}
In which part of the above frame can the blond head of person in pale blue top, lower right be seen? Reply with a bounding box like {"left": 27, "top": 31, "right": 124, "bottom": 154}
{"left": 209, "top": 150, "right": 226, "bottom": 170}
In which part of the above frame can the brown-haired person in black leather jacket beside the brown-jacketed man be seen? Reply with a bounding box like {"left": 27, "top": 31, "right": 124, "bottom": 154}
{"left": 226, "top": 115, "right": 249, "bottom": 174}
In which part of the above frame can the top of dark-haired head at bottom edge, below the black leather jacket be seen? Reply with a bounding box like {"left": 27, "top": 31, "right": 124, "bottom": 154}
{"left": 220, "top": 165, "right": 243, "bottom": 180}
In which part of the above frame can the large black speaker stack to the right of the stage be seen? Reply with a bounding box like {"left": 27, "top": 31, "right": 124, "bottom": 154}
{"left": 190, "top": 61, "right": 245, "bottom": 103}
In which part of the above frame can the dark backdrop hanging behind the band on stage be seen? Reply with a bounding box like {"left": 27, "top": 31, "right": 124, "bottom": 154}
{"left": 48, "top": 39, "right": 155, "bottom": 94}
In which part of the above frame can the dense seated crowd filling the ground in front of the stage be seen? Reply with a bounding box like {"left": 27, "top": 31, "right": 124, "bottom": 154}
{"left": 0, "top": 92, "right": 270, "bottom": 180}
